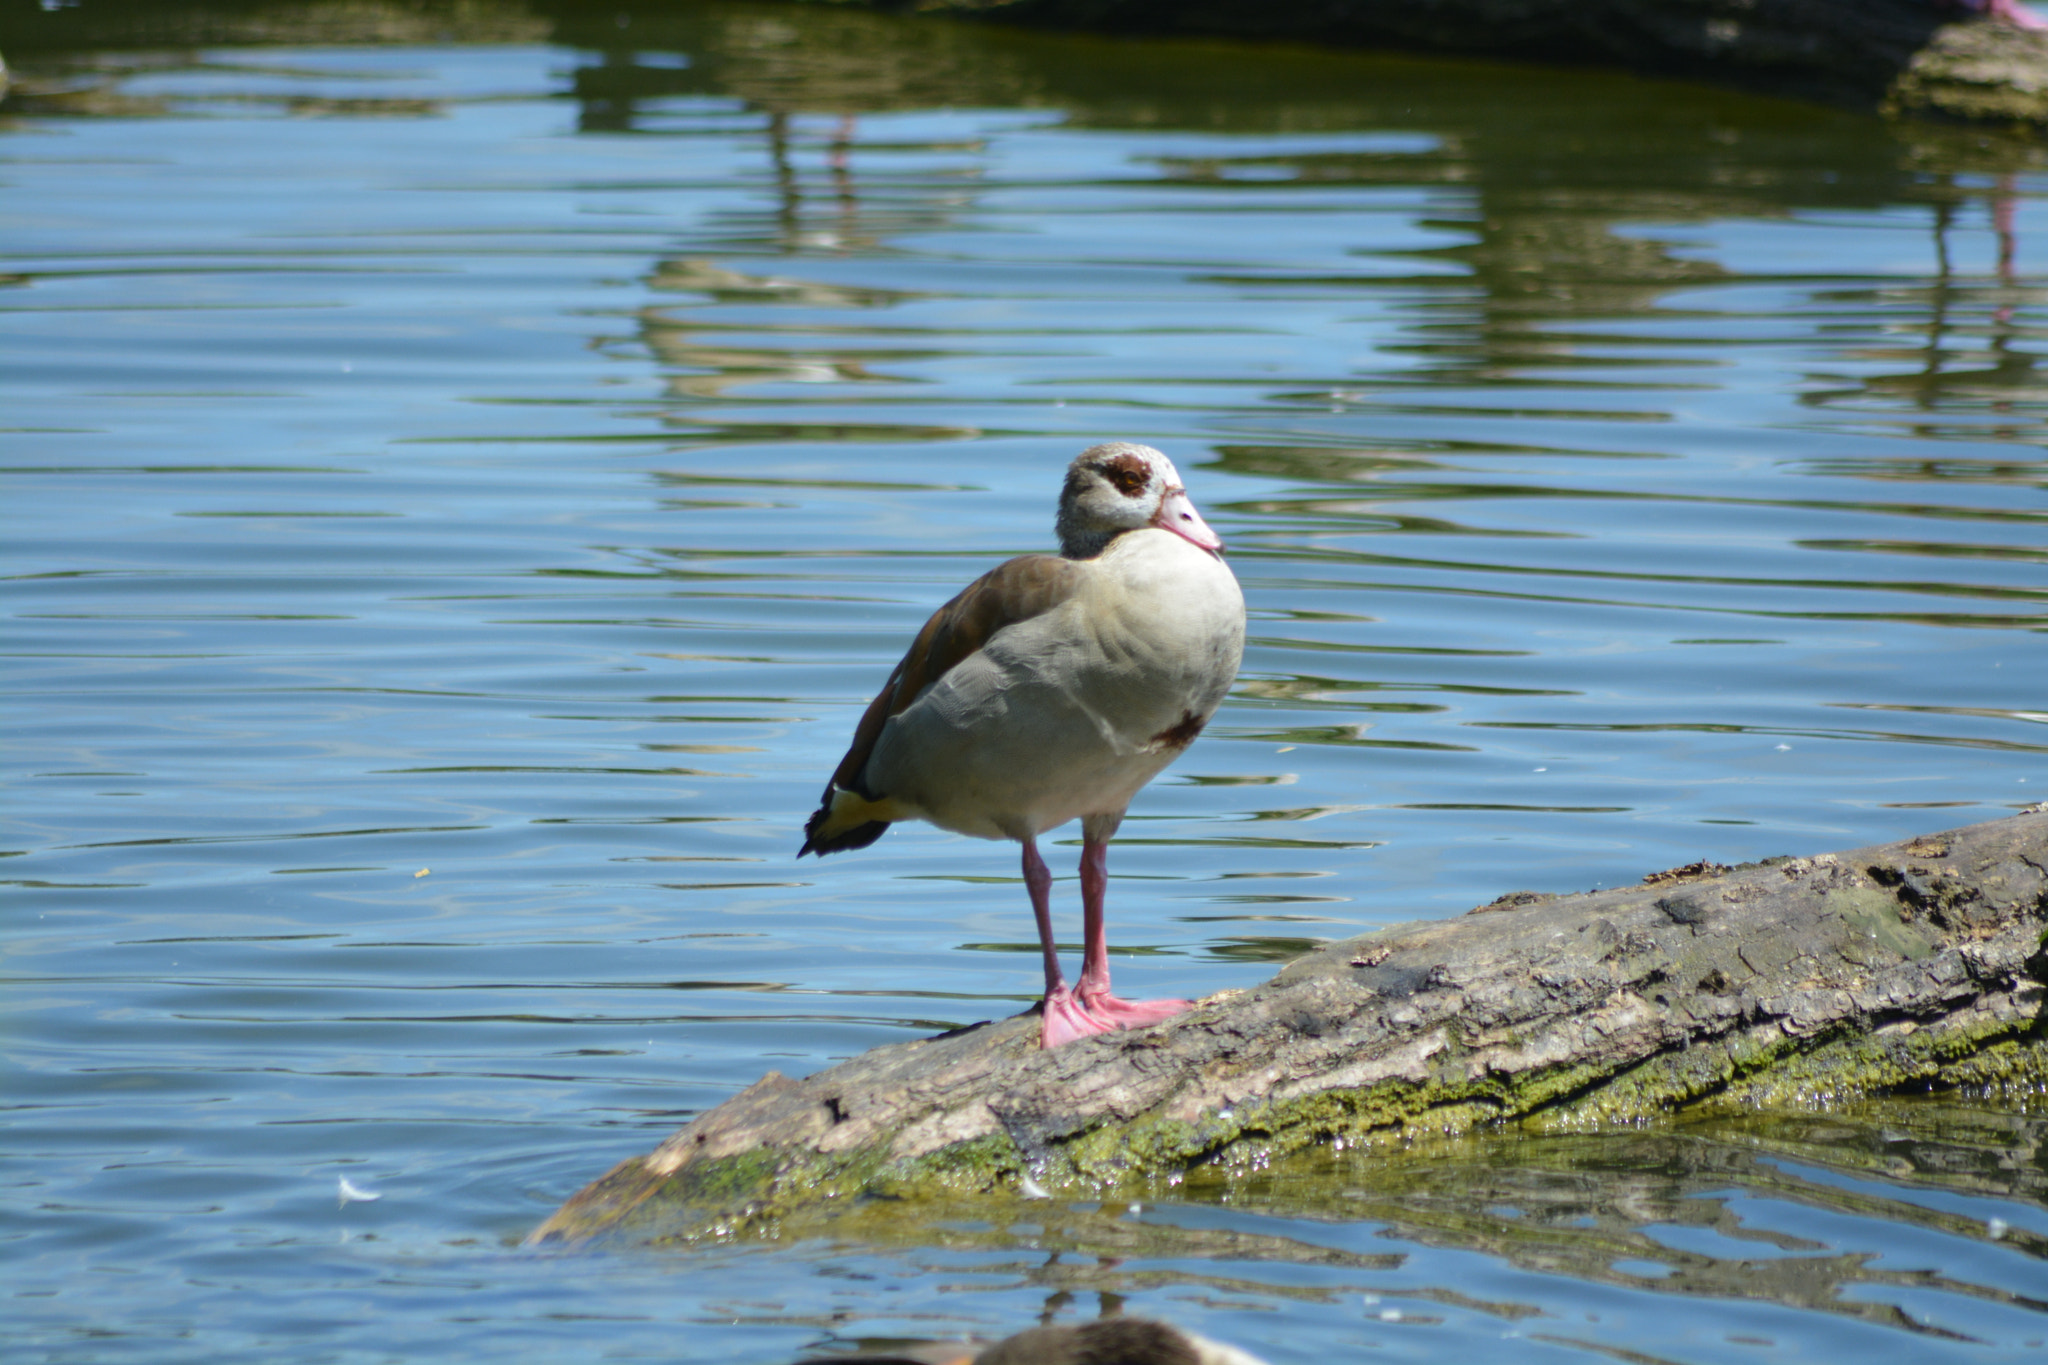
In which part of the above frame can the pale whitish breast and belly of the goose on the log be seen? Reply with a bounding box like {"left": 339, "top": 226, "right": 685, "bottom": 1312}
{"left": 866, "top": 528, "right": 1245, "bottom": 839}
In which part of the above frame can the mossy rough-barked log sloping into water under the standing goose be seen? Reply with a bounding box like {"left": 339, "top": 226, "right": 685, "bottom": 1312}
{"left": 528, "top": 806, "right": 2048, "bottom": 1242}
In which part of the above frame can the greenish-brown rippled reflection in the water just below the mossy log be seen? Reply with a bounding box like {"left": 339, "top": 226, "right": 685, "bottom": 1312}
{"left": 651, "top": 1085, "right": 2048, "bottom": 1334}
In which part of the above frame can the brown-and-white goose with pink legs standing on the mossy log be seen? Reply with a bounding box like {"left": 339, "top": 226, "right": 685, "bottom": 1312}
{"left": 797, "top": 442, "right": 1245, "bottom": 1048}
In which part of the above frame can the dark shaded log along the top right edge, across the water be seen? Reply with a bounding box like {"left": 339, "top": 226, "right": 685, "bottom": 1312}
{"left": 802, "top": 0, "right": 2048, "bottom": 129}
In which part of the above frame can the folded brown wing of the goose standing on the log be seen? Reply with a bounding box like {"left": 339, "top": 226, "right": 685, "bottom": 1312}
{"left": 797, "top": 555, "right": 1085, "bottom": 857}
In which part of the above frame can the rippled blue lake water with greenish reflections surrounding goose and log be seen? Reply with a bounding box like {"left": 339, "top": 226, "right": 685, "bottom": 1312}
{"left": 0, "top": 0, "right": 2048, "bottom": 1365}
